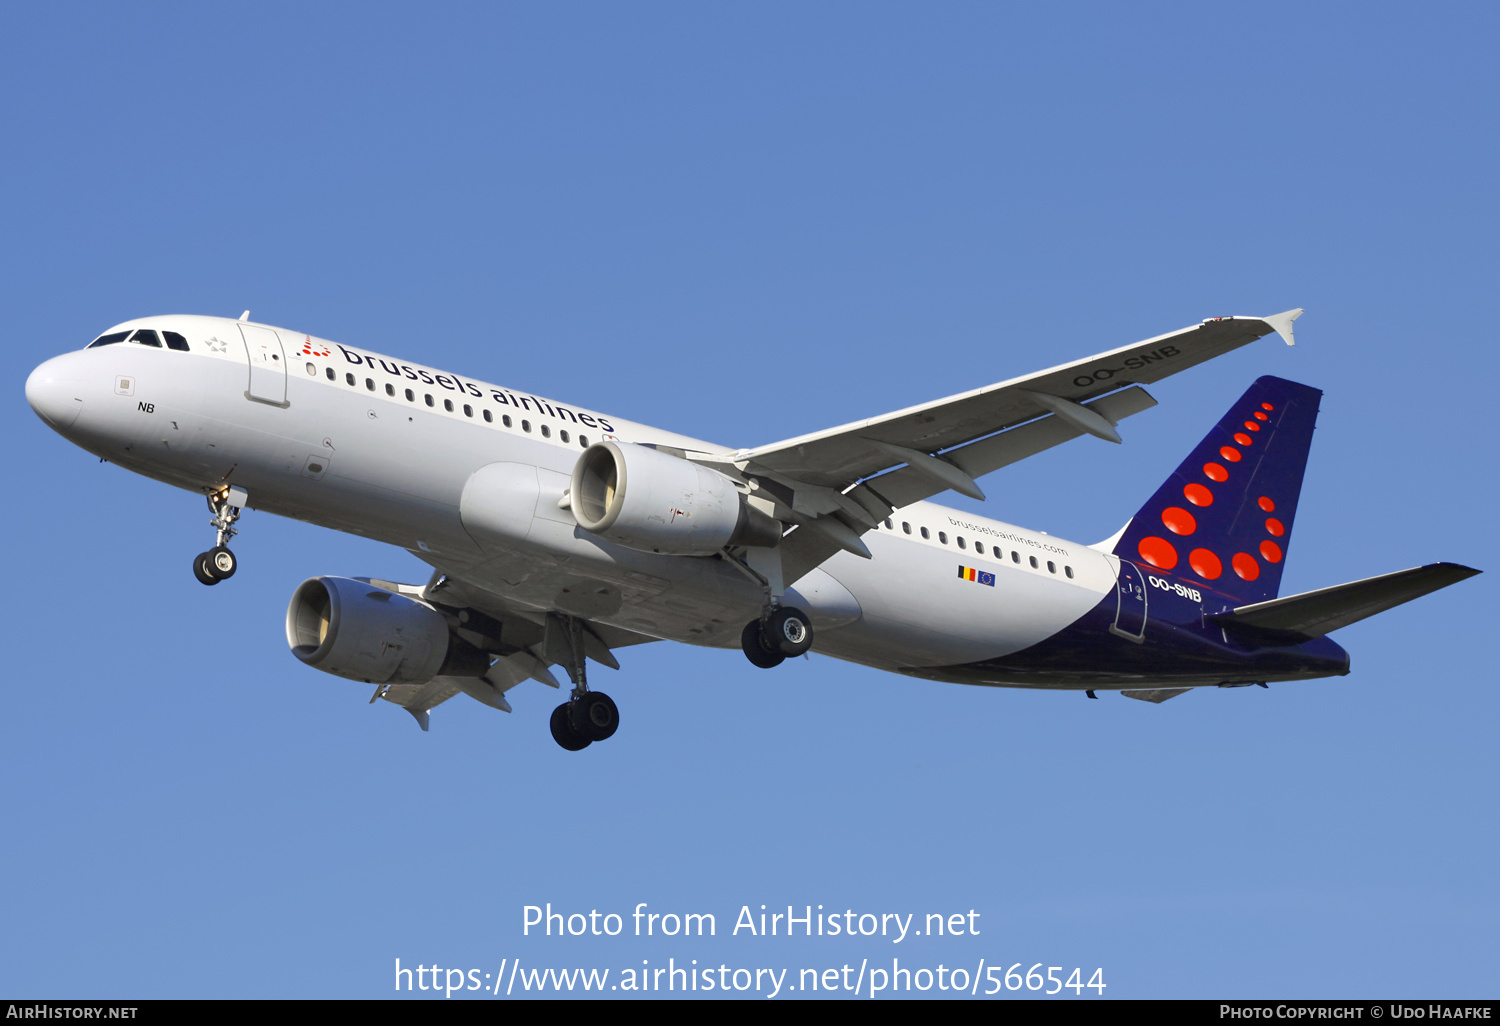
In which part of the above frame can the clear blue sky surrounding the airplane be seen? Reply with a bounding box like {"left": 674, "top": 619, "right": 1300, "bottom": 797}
{"left": 0, "top": 3, "right": 1500, "bottom": 999}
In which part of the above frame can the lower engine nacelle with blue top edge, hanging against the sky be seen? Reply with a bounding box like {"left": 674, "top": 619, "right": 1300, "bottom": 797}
{"left": 287, "top": 578, "right": 489, "bottom": 684}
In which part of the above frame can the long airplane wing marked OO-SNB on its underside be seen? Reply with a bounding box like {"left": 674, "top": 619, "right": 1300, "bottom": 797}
{"left": 689, "top": 309, "right": 1302, "bottom": 581}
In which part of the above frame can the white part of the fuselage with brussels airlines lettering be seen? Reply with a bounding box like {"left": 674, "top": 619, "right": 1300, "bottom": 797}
{"left": 27, "top": 317, "right": 1118, "bottom": 675}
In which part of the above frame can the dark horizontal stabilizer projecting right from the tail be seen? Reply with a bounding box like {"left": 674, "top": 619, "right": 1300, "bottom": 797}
{"left": 1209, "top": 563, "right": 1479, "bottom": 641}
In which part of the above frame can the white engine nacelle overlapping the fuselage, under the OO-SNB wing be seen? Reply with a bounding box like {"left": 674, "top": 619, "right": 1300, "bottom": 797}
{"left": 569, "top": 441, "right": 782, "bottom": 555}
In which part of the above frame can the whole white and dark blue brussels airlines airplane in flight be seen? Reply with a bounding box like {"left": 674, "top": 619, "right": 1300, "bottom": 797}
{"left": 26, "top": 309, "right": 1479, "bottom": 752}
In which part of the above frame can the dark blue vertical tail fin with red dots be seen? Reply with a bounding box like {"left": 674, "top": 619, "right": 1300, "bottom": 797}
{"left": 1115, "top": 377, "right": 1323, "bottom": 605}
